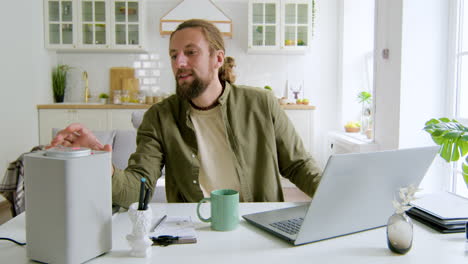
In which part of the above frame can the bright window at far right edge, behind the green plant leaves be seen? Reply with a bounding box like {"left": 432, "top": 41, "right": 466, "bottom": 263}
{"left": 451, "top": 0, "right": 468, "bottom": 197}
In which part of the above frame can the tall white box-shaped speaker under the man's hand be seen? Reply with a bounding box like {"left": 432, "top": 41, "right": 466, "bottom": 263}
{"left": 24, "top": 147, "right": 112, "bottom": 264}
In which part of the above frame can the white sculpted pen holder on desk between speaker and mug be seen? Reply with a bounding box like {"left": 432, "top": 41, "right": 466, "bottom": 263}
{"left": 127, "top": 203, "right": 153, "bottom": 258}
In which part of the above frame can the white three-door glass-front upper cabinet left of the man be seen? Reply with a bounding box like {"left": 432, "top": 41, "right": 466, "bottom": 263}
{"left": 44, "top": 0, "right": 143, "bottom": 51}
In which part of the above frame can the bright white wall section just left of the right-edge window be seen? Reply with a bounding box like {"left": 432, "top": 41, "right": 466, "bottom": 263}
{"left": 399, "top": 0, "right": 454, "bottom": 191}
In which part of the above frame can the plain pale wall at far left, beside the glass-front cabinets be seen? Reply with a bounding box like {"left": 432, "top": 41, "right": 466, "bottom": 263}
{"left": 0, "top": 0, "right": 53, "bottom": 176}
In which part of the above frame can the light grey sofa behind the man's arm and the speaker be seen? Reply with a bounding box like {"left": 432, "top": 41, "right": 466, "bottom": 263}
{"left": 52, "top": 110, "right": 167, "bottom": 203}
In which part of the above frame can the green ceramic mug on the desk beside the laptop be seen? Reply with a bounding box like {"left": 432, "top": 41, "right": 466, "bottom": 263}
{"left": 197, "top": 189, "right": 239, "bottom": 231}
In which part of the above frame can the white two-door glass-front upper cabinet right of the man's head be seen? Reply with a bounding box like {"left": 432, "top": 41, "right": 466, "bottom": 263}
{"left": 248, "top": 0, "right": 314, "bottom": 53}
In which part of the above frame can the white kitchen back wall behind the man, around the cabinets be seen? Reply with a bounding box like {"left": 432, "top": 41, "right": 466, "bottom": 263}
{"left": 57, "top": 0, "right": 338, "bottom": 164}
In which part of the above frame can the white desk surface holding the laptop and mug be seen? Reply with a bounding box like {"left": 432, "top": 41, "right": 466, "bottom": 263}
{"left": 0, "top": 203, "right": 468, "bottom": 264}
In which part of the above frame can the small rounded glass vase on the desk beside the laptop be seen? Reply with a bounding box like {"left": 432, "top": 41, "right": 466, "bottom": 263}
{"left": 387, "top": 212, "right": 413, "bottom": 254}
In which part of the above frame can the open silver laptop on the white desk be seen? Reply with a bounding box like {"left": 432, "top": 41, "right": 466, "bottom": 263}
{"left": 242, "top": 146, "right": 439, "bottom": 246}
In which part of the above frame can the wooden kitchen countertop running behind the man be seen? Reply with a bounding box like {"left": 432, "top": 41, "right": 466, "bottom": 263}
{"left": 37, "top": 103, "right": 316, "bottom": 110}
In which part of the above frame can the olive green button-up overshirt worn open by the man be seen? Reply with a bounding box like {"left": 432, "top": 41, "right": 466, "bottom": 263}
{"left": 112, "top": 82, "right": 321, "bottom": 207}
